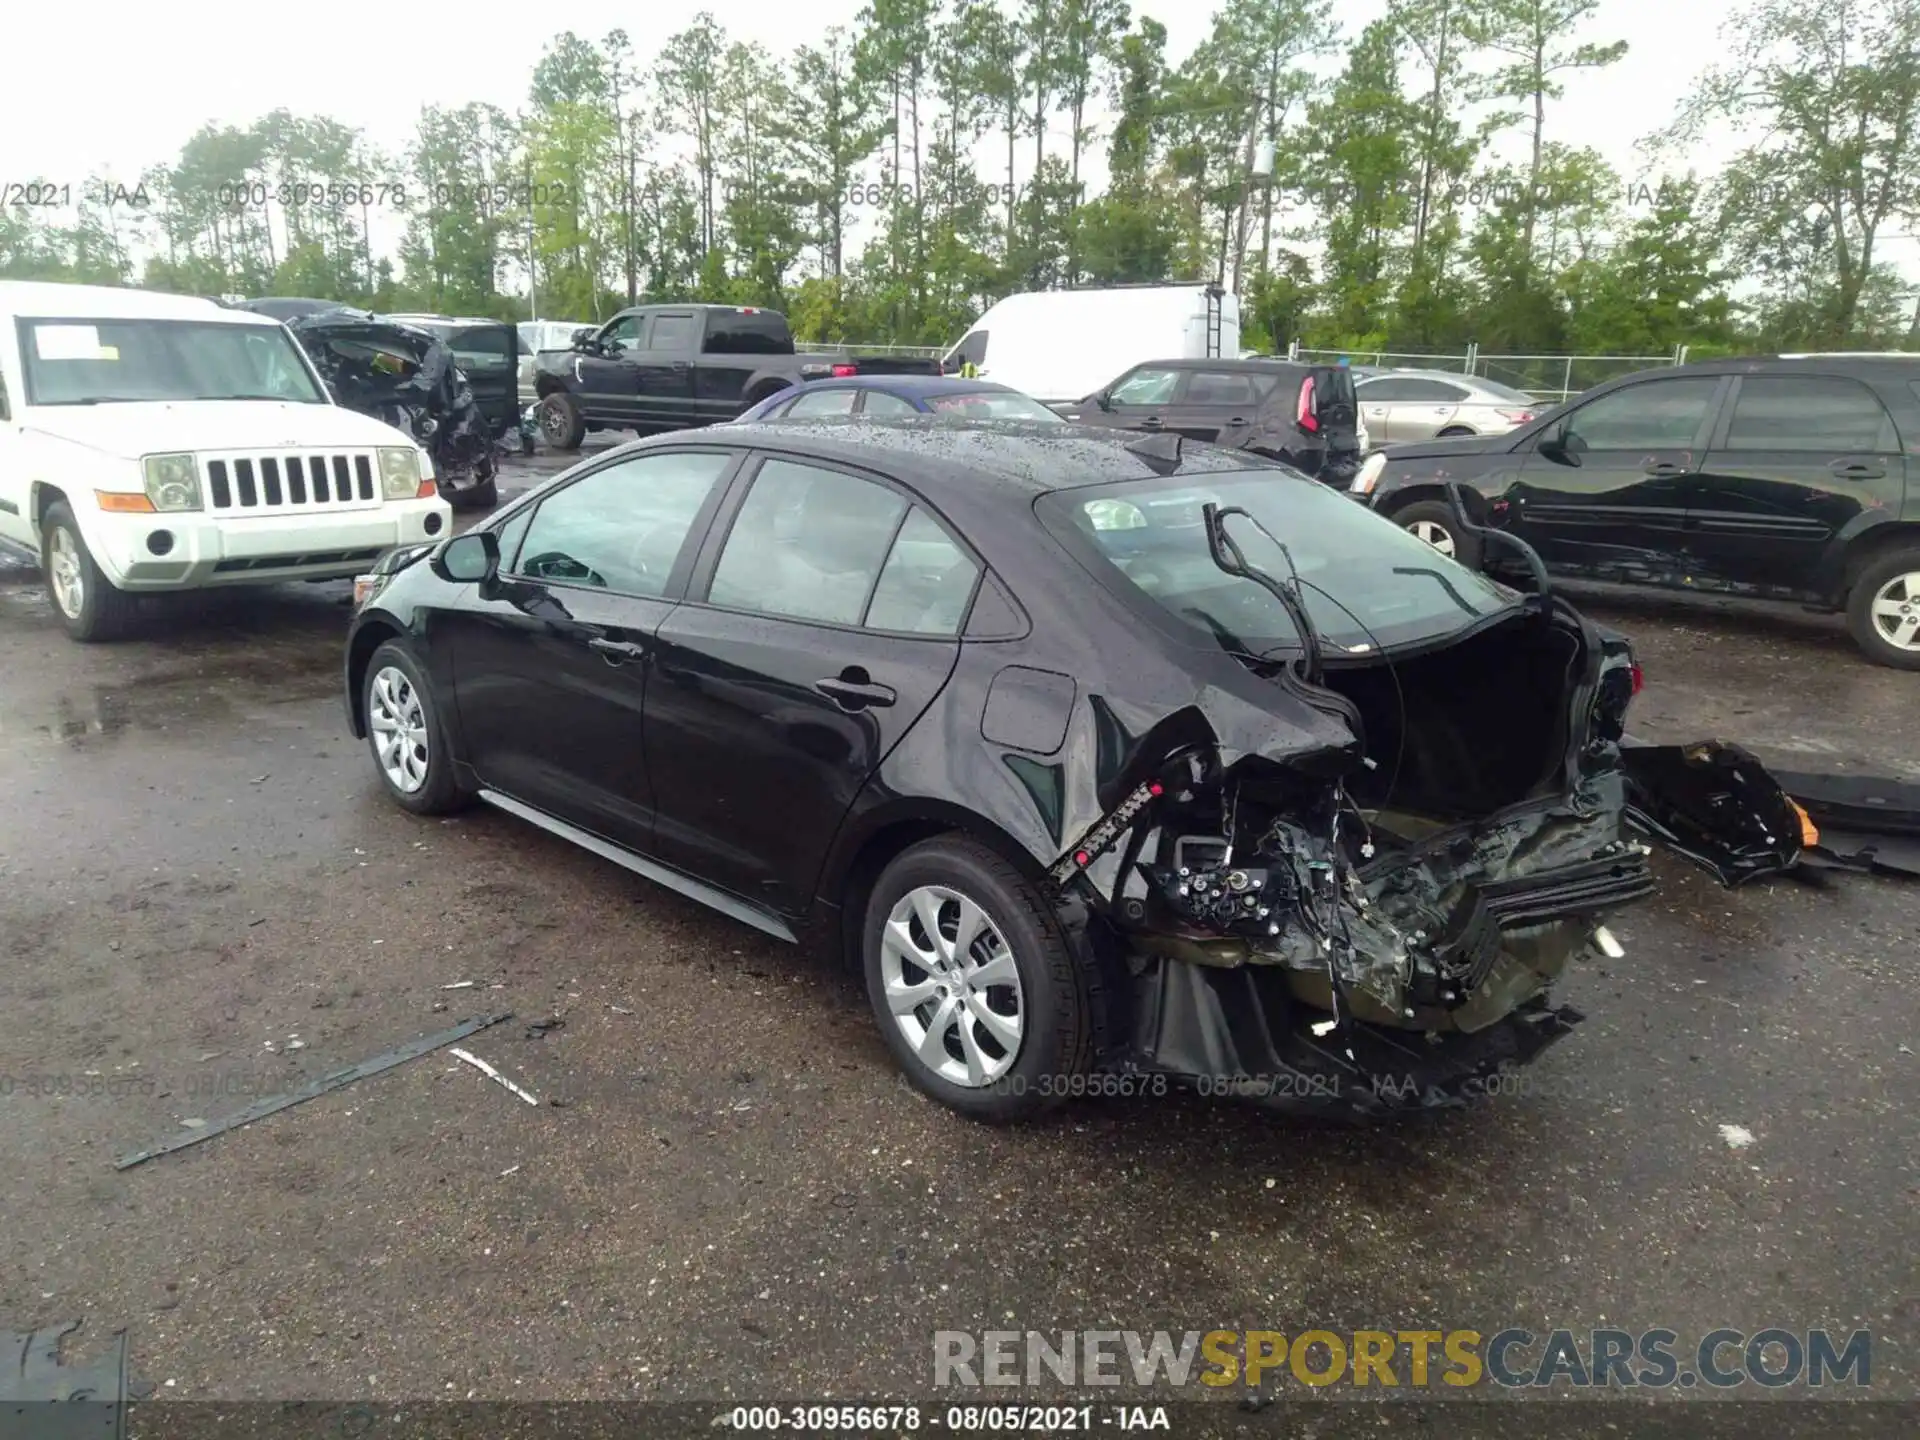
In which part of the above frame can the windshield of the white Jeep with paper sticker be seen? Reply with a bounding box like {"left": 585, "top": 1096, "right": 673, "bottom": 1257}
{"left": 19, "top": 319, "right": 328, "bottom": 405}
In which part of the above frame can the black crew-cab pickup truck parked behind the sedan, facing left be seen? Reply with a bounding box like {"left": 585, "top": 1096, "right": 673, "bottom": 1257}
{"left": 534, "top": 305, "right": 941, "bottom": 449}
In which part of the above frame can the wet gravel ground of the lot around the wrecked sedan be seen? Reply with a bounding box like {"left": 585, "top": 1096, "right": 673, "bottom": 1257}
{"left": 0, "top": 449, "right": 1920, "bottom": 1434}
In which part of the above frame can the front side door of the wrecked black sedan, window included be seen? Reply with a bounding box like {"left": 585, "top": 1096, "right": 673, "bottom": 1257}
{"left": 436, "top": 449, "right": 735, "bottom": 851}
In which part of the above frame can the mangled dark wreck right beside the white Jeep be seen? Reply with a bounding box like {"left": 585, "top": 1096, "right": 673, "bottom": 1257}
{"left": 286, "top": 309, "right": 513, "bottom": 511}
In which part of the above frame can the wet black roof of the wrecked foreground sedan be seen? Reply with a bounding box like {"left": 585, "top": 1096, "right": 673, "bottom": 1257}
{"left": 668, "top": 415, "right": 1267, "bottom": 503}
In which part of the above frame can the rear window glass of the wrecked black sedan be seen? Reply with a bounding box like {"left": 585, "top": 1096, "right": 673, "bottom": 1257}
{"left": 1039, "top": 470, "right": 1513, "bottom": 655}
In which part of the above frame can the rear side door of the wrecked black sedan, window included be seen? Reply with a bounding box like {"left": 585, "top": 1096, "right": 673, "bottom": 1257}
{"left": 647, "top": 457, "right": 981, "bottom": 916}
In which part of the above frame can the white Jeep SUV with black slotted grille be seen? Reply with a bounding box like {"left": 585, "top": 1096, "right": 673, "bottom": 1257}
{"left": 0, "top": 282, "right": 451, "bottom": 639}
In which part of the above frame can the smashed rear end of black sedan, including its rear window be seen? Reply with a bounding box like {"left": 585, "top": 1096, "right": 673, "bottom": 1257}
{"left": 1041, "top": 445, "right": 1653, "bottom": 1117}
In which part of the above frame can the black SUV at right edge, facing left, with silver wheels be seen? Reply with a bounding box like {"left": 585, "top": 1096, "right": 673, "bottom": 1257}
{"left": 1352, "top": 353, "right": 1920, "bottom": 670}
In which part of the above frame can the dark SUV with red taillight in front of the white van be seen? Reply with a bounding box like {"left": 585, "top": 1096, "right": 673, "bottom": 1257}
{"left": 1056, "top": 359, "right": 1359, "bottom": 486}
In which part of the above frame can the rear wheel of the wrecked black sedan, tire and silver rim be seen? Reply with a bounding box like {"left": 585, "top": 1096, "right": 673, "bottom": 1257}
{"left": 860, "top": 835, "right": 1094, "bottom": 1123}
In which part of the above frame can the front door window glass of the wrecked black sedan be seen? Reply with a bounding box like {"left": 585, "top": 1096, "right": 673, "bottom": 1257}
{"left": 503, "top": 451, "right": 732, "bottom": 595}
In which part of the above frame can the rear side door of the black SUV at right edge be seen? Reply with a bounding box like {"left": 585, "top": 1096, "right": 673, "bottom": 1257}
{"left": 1688, "top": 374, "right": 1908, "bottom": 595}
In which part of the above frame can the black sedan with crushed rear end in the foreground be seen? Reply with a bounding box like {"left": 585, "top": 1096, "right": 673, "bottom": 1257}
{"left": 346, "top": 420, "right": 1651, "bottom": 1119}
